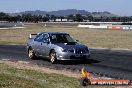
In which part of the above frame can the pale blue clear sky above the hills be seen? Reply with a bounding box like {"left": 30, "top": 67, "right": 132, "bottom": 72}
{"left": 0, "top": 0, "right": 132, "bottom": 16}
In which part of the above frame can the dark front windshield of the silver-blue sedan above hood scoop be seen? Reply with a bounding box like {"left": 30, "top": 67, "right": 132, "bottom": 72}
{"left": 50, "top": 34, "right": 76, "bottom": 43}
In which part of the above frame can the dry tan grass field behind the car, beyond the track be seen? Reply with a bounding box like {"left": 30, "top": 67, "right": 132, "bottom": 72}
{"left": 0, "top": 24, "right": 132, "bottom": 49}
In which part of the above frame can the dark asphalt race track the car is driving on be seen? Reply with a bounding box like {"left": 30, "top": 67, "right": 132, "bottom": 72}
{"left": 0, "top": 45, "right": 132, "bottom": 80}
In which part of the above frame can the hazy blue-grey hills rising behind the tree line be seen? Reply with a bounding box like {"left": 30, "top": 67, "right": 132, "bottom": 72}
{"left": 11, "top": 9, "right": 117, "bottom": 17}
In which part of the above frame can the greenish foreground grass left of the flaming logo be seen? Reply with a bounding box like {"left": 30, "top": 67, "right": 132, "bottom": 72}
{"left": 0, "top": 64, "right": 81, "bottom": 88}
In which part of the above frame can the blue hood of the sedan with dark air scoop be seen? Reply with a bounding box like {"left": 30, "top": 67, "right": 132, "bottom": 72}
{"left": 54, "top": 43, "right": 87, "bottom": 49}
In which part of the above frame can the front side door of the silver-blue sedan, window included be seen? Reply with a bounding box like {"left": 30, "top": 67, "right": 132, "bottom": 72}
{"left": 40, "top": 34, "right": 49, "bottom": 57}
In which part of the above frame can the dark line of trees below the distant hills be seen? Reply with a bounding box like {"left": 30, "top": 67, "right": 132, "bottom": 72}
{"left": 0, "top": 12, "right": 132, "bottom": 23}
